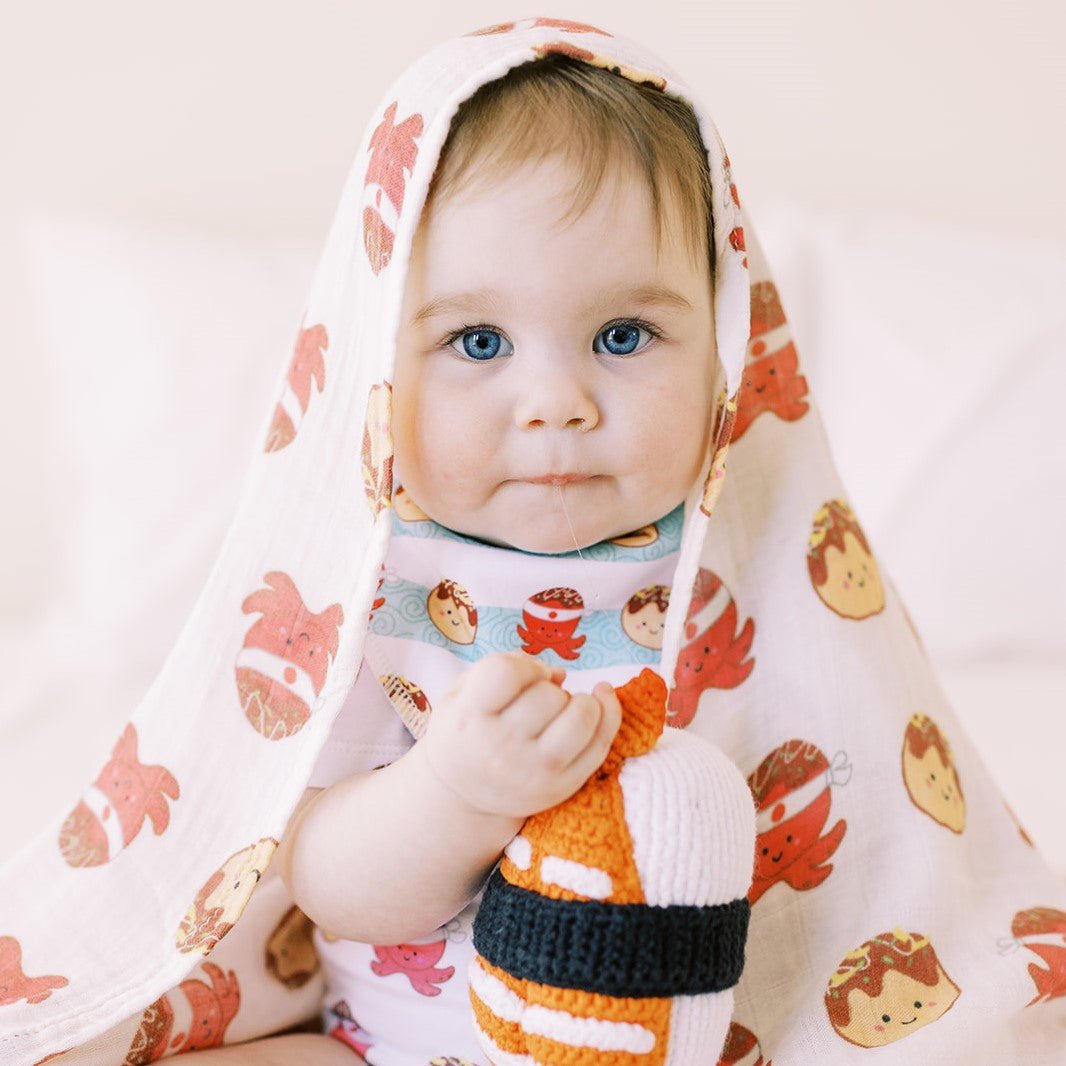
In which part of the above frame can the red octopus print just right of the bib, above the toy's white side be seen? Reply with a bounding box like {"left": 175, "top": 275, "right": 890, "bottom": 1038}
{"left": 666, "top": 566, "right": 755, "bottom": 729}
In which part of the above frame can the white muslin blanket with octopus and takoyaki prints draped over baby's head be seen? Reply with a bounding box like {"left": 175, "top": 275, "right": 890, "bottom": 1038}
{"left": 6, "top": 18, "right": 1066, "bottom": 1064}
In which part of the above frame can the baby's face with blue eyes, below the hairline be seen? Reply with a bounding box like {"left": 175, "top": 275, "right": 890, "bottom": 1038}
{"left": 392, "top": 159, "right": 716, "bottom": 552}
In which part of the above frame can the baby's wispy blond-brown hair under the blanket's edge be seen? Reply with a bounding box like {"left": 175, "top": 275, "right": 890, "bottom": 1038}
{"left": 426, "top": 52, "right": 714, "bottom": 277}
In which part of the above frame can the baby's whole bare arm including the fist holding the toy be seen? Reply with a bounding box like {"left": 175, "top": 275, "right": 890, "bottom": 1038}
{"left": 275, "top": 652, "right": 621, "bottom": 943}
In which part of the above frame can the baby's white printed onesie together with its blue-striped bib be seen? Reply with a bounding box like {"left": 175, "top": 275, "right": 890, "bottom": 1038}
{"left": 308, "top": 489, "right": 683, "bottom": 1066}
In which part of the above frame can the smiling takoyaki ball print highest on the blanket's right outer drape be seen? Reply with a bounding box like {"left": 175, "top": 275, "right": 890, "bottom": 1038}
{"left": 807, "top": 500, "right": 885, "bottom": 618}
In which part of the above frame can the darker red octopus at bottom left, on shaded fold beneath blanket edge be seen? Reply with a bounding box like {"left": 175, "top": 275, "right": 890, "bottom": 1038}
{"left": 123, "top": 963, "right": 241, "bottom": 1066}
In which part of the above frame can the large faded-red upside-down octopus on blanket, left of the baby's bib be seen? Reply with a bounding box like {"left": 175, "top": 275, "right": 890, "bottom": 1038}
{"left": 236, "top": 570, "right": 344, "bottom": 740}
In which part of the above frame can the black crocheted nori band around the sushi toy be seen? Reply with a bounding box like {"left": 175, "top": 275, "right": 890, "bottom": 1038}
{"left": 473, "top": 867, "right": 752, "bottom": 998}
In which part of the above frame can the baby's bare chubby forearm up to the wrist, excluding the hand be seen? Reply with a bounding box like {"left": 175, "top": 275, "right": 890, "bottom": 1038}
{"left": 275, "top": 743, "right": 523, "bottom": 943}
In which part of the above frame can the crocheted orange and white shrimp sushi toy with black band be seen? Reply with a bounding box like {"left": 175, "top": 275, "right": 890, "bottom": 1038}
{"left": 469, "top": 667, "right": 755, "bottom": 1066}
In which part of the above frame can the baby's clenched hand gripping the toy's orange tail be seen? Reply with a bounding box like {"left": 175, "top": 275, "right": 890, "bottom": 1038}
{"left": 419, "top": 651, "right": 621, "bottom": 818}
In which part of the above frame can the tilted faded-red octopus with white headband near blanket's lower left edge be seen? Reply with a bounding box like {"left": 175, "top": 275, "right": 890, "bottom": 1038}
{"left": 59, "top": 722, "right": 179, "bottom": 867}
